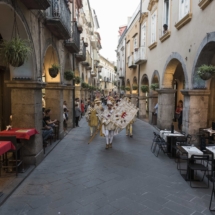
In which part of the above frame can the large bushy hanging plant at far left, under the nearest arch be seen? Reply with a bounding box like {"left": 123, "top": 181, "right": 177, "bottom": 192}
{"left": 0, "top": 37, "right": 32, "bottom": 67}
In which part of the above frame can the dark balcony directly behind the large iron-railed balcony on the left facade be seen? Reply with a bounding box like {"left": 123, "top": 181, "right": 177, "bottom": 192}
{"left": 64, "top": 22, "right": 80, "bottom": 53}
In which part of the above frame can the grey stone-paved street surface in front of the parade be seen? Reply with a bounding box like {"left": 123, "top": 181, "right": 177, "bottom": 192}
{"left": 0, "top": 120, "right": 215, "bottom": 215}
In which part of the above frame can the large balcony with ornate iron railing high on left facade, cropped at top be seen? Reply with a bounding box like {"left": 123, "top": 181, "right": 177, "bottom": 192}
{"left": 45, "top": 0, "right": 71, "bottom": 40}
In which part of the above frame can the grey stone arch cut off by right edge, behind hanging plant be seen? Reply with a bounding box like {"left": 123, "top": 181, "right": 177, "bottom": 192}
{"left": 192, "top": 32, "right": 215, "bottom": 89}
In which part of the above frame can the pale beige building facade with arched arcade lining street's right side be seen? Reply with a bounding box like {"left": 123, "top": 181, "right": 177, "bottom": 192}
{"left": 116, "top": 0, "right": 215, "bottom": 134}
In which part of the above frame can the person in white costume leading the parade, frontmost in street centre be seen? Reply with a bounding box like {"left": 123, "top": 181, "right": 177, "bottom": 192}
{"left": 102, "top": 100, "right": 116, "bottom": 149}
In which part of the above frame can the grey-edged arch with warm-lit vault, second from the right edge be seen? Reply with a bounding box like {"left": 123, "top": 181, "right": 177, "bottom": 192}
{"left": 162, "top": 52, "right": 189, "bottom": 89}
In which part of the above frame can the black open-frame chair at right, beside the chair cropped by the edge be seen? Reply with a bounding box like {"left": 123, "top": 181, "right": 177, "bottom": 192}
{"left": 187, "top": 155, "right": 210, "bottom": 188}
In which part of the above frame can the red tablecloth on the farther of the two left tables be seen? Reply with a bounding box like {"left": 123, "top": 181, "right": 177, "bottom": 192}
{"left": 0, "top": 128, "right": 39, "bottom": 140}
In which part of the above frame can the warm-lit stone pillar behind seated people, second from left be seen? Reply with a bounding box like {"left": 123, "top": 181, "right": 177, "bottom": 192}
{"left": 46, "top": 83, "right": 66, "bottom": 139}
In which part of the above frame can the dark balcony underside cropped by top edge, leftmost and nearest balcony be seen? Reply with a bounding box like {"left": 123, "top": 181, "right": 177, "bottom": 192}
{"left": 21, "top": 0, "right": 51, "bottom": 10}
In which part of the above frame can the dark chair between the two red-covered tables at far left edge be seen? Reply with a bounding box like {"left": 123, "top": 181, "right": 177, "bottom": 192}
{"left": 0, "top": 136, "right": 23, "bottom": 176}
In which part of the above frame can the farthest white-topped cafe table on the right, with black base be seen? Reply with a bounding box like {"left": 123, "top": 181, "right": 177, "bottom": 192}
{"left": 160, "top": 130, "right": 184, "bottom": 157}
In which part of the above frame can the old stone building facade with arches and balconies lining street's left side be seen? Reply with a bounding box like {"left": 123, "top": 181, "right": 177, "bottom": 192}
{"left": 0, "top": 0, "right": 101, "bottom": 164}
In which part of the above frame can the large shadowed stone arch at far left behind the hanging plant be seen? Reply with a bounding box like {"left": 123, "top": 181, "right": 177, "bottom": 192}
{"left": 0, "top": 0, "right": 39, "bottom": 80}
